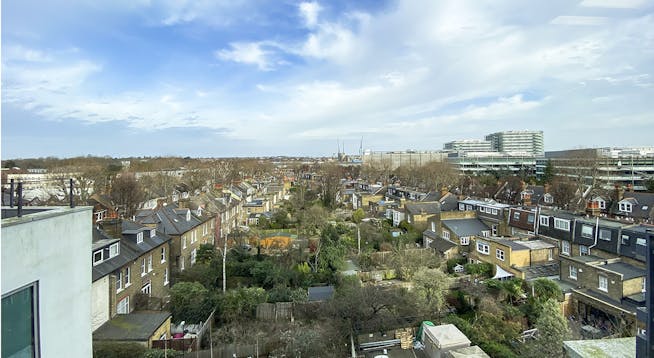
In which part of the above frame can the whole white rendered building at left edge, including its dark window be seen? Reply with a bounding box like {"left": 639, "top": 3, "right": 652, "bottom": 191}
{"left": 1, "top": 207, "right": 93, "bottom": 357}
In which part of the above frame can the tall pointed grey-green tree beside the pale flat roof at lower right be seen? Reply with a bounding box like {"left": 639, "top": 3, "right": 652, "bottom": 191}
{"left": 522, "top": 299, "right": 570, "bottom": 357}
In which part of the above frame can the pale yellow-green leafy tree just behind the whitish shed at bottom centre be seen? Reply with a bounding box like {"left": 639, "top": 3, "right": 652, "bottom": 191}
{"left": 413, "top": 268, "right": 449, "bottom": 317}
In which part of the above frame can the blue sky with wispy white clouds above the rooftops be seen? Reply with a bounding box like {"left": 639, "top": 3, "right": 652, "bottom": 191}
{"left": 1, "top": 0, "right": 654, "bottom": 159}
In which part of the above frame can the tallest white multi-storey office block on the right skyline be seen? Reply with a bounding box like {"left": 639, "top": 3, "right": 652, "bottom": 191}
{"left": 485, "top": 131, "right": 544, "bottom": 157}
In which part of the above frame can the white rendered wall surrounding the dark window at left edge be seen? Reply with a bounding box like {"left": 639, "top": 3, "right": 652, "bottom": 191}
{"left": 1, "top": 207, "right": 93, "bottom": 357}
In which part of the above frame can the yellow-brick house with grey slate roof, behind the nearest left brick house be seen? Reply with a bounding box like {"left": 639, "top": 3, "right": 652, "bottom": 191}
{"left": 136, "top": 202, "right": 215, "bottom": 271}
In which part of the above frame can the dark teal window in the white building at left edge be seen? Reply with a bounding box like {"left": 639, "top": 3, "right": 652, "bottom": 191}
{"left": 2, "top": 283, "right": 39, "bottom": 357}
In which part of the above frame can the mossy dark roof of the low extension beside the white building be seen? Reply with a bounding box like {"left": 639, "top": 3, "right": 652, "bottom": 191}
{"left": 93, "top": 311, "right": 171, "bottom": 342}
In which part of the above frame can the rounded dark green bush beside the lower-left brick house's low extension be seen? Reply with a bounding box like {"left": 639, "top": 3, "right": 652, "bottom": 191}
{"left": 170, "top": 282, "right": 214, "bottom": 323}
